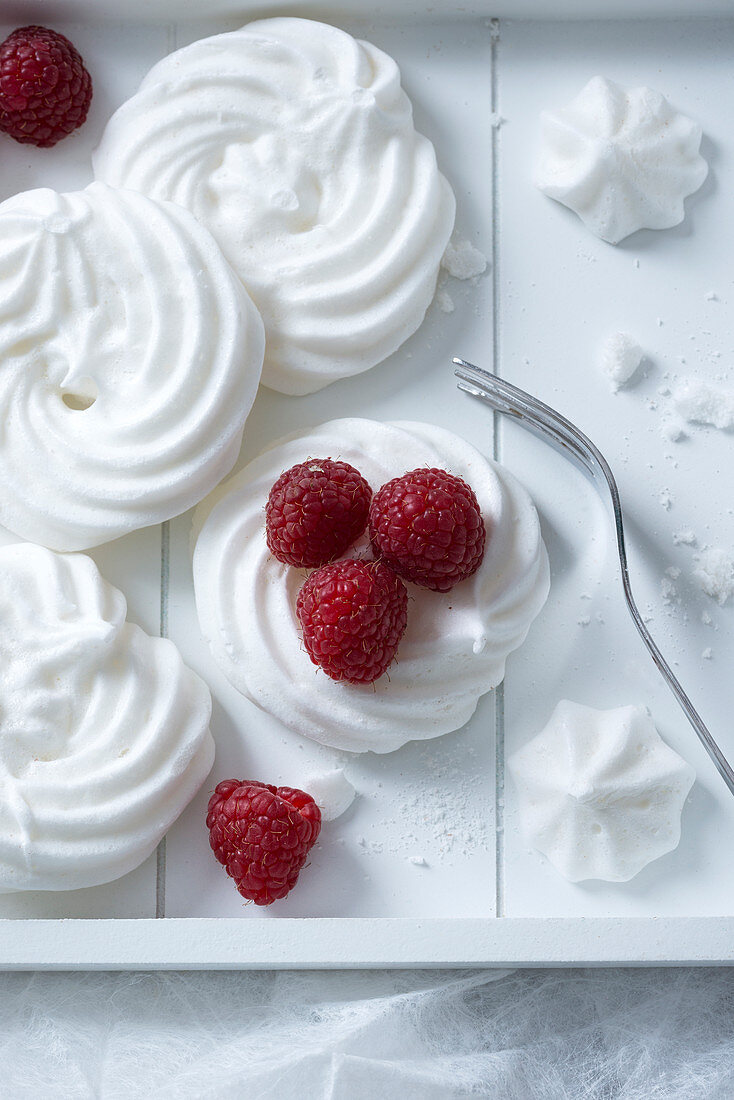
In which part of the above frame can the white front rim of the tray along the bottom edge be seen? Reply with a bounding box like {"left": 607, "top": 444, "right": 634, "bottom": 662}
{"left": 0, "top": 916, "right": 734, "bottom": 970}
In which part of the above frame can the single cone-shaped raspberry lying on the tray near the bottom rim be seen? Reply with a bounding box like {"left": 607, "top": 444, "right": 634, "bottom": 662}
{"left": 207, "top": 779, "right": 321, "bottom": 905}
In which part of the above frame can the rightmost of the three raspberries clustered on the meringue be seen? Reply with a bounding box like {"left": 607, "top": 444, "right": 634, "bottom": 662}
{"left": 370, "top": 470, "right": 486, "bottom": 592}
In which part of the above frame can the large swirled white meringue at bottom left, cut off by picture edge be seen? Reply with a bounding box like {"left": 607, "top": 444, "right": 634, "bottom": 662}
{"left": 0, "top": 543, "right": 213, "bottom": 893}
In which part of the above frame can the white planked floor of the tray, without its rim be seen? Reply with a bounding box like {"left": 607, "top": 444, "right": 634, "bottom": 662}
{"left": 0, "top": 6, "right": 734, "bottom": 954}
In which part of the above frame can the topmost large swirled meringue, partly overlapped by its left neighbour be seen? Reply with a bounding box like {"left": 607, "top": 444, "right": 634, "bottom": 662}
{"left": 94, "top": 19, "right": 456, "bottom": 394}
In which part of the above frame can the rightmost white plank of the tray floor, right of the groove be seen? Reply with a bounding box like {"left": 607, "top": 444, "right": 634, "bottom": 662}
{"left": 497, "top": 22, "right": 734, "bottom": 916}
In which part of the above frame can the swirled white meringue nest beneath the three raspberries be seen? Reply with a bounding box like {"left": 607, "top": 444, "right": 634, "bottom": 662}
{"left": 194, "top": 419, "right": 549, "bottom": 752}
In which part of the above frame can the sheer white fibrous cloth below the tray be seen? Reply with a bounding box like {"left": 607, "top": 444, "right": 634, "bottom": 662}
{"left": 0, "top": 969, "right": 734, "bottom": 1100}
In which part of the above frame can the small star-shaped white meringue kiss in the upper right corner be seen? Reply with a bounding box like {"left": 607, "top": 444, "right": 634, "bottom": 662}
{"left": 535, "top": 76, "right": 709, "bottom": 244}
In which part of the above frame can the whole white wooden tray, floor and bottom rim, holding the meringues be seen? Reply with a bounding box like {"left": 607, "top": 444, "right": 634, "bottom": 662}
{"left": 0, "top": 0, "right": 734, "bottom": 969}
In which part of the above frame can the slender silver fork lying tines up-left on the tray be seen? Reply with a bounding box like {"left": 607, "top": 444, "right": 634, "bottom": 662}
{"left": 453, "top": 359, "right": 734, "bottom": 794}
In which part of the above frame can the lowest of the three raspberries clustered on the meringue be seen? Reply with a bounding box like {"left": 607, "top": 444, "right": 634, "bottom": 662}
{"left": 296, "top": 558, "right": 408, "bottom": 684}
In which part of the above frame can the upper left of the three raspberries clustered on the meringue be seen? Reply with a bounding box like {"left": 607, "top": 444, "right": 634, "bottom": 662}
{"left": 265, "top": 459, "right": 372, "bottom": 568}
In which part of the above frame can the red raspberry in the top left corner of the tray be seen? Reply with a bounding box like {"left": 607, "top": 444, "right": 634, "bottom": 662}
{"left": 0, "top": 26, "right": 91, "bottom": 149}
